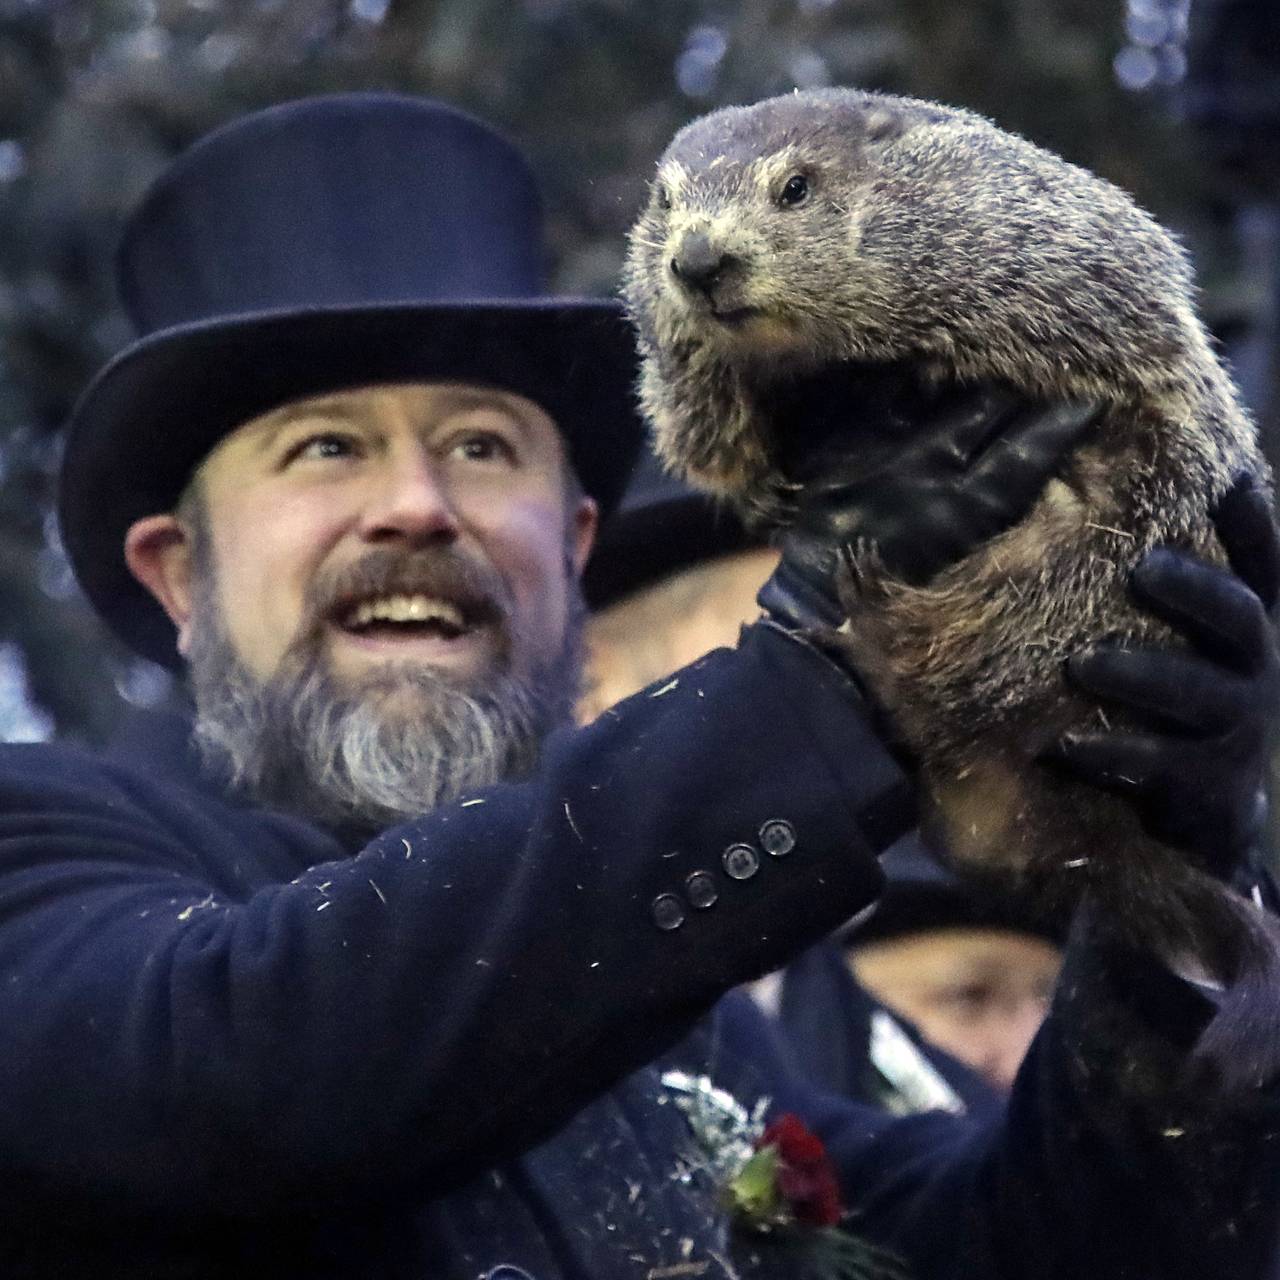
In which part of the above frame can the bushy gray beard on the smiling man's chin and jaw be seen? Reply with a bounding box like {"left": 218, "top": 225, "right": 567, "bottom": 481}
{"left": 189, "top": 590, "right": 584, "bottom": 832}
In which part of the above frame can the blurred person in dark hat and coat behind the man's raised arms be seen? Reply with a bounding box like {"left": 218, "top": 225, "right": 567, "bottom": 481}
{"left": 777, "top": 832, "right": 1066, "bottom": 1111}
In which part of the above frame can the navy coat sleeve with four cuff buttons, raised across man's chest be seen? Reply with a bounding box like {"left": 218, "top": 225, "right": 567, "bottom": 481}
{"left": 0, "top": 625, "right": 911, "bottom": 1216}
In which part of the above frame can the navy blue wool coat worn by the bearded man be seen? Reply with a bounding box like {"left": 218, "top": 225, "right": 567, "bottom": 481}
{"left": 0, "top": 628, "right": 1280, "bottom": 1280}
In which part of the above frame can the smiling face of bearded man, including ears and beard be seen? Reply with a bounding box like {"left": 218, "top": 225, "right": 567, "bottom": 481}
{"left": 127, "top": 384, "right": 595, "bottom": 827}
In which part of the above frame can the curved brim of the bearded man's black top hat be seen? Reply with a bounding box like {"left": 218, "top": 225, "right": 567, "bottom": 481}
{"left": 59, "top": 298, "right": 644, "bottom": 667}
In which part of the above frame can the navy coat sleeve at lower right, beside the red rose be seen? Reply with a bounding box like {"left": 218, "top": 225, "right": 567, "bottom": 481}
{"left": 752, "top": 918, "right": 1280, "bottom": 1280}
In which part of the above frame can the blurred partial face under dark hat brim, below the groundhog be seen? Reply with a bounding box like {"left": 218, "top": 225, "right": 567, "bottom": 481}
{"left": 849, "top": 928, "right": 1061, "bottom": 1089}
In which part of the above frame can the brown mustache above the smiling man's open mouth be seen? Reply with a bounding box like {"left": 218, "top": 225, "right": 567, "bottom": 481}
{"left": 300, "top": 547, "right": 515, "bottom": 636}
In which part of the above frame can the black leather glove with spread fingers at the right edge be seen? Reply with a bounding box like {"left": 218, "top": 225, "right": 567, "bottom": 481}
{"left": 1048, "top": 479, "right": 1280, "bottom": 896}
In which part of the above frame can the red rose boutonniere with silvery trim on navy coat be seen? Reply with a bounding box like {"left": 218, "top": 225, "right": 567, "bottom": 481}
{"left": 662, "top": 1071, "right": 908, "bottom": 1280}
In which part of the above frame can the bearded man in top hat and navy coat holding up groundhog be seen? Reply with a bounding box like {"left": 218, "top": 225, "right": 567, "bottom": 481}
{"left": 0, "top": 95, "right": 1280, "bottom": 1280}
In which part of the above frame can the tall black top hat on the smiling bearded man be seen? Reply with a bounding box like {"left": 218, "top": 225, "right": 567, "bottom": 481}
{"left": 59, "top": 93, "right": 643, "bottom": 666}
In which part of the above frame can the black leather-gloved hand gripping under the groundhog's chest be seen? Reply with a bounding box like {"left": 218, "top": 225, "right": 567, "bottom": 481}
{"left": 756, "top": 387, "right": 1102, "bottom": 628}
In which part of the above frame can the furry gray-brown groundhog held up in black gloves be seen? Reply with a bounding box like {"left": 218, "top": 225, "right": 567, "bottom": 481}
{"left": 623, "top": 90, "right": 1280, "bottom": 1082}
